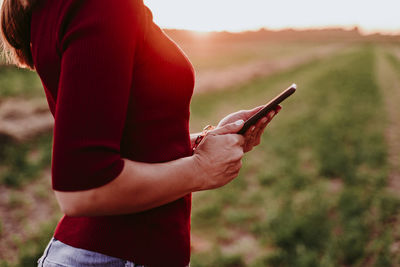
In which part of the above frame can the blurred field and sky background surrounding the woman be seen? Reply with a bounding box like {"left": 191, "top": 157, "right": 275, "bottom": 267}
{"left": 0, "top": 0, "right": 400, "bottom": 267}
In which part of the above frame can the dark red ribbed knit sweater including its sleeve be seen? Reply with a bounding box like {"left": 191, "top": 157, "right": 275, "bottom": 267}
{"left": 31, "top": 0, "right": 194, "bottom": 266}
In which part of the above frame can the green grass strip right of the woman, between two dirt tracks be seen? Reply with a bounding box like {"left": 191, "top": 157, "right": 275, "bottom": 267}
{"left": 192, "top": 45, "right": 400, "bottom": 266}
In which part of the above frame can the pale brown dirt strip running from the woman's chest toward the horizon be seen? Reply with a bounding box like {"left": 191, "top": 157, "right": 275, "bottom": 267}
{"left": 195, "top": 44, "right": 345, "bottom": 93}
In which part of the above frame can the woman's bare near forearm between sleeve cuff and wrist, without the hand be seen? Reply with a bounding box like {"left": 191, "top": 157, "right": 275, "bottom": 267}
{"left": 55, "top": 157, "right": 200, "bottom": 216}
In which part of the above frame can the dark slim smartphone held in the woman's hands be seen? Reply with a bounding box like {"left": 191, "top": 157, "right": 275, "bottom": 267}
{"left": 237, "top": 84, "right": 297, "bottom": 135}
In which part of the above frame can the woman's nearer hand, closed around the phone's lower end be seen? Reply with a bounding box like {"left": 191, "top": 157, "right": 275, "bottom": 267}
{"left": 193, "top": 120, "right": 244, "bottom": 191}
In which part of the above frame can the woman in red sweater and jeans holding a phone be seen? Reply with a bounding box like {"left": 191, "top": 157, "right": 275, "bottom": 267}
{"left": 1, "top": 0, "right": 280, "bottom": 266}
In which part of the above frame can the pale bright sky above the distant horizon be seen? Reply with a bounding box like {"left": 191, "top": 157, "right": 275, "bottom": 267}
{"left": 144, "top": 0, "right": 400, "bottom": 34}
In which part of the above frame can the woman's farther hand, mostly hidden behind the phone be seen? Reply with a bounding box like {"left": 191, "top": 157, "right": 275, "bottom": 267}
{"left": 217, "top": 105, "right": 282, "bottom": 152}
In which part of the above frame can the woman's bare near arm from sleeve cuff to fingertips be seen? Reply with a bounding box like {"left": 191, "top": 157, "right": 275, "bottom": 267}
{"left": 55, "top": 121, "right": 244, "bottom": 216}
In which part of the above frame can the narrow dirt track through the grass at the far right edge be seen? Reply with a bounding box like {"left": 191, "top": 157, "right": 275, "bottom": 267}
{"left": 377, "top": 51, "right": 400, "bottom": 193}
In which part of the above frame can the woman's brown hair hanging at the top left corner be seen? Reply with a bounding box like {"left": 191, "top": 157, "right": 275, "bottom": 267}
{"left": 0, "top": 0, "right": 37, "bottom": 69}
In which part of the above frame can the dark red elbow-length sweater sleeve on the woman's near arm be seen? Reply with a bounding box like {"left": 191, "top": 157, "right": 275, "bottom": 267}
{"left": 52, "top": 0, "right": 143, "bottom": 191}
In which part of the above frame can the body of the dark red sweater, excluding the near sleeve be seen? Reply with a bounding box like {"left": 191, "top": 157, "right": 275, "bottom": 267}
{"left": 32, "top": 0, "right": 194, "bottom": 266}
